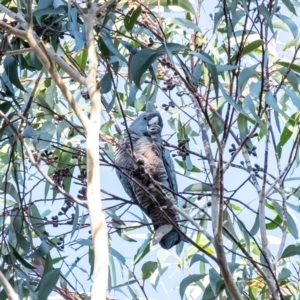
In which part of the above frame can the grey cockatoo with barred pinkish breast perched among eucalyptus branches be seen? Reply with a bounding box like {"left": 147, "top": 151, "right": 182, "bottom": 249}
{"left": 115, "top": 103, "right": 182, "bottom": 249}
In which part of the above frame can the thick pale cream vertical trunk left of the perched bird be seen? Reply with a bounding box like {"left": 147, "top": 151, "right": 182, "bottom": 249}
{"left": 83, "top": 5, "right": 108, "bottom": 300}
